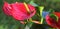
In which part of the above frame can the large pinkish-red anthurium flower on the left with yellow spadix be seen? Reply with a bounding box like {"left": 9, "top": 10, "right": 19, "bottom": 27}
{"left": 3, "top": 2, "right": 36, "bottom": 20}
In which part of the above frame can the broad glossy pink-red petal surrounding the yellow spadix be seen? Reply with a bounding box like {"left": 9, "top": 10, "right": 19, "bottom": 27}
{"left": 11, "top": 3, "right": 36, "bottom": 20}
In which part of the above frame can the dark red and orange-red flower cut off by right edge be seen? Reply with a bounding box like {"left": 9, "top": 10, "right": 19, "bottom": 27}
{"left": 46, "top": 12, "right": 60, "bottom": 29}
